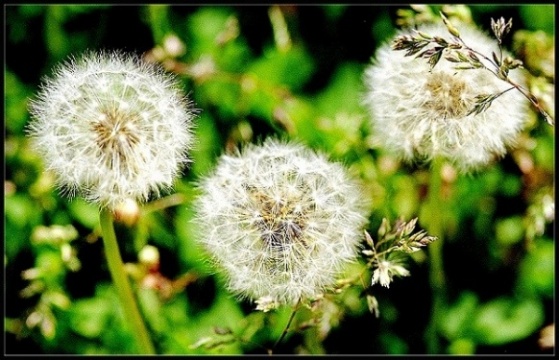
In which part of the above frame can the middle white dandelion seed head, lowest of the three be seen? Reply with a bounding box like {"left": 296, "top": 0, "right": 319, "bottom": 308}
{"left": 196, "top": 139, "right": 367, "bottom": 304}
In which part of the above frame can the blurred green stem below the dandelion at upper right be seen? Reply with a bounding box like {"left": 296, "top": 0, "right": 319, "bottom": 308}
{"left": 426, "top": 159, "right": 446, "bottom": 354}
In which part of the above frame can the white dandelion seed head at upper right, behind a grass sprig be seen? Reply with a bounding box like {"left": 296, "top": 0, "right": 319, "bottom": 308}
{"left": 364, "top": 24, "right": 528, "bottom": 172}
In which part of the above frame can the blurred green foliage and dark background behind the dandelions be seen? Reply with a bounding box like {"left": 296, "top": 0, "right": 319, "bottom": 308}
{"left": 4, "top": 5, "right": 555, "bottom": 354}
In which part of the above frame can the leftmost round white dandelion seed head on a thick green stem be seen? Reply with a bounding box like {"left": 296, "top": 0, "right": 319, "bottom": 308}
{"left": 27, "top": 52, "right": 195, "bottom": 209}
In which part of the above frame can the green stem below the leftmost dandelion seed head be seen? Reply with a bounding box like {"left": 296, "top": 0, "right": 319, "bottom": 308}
{"left": 100, "top": 209, "right": 155, "bottom": 354}
